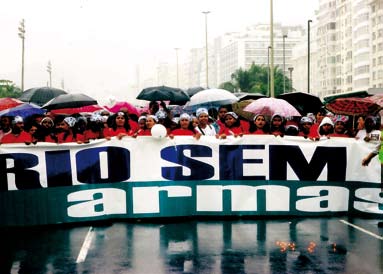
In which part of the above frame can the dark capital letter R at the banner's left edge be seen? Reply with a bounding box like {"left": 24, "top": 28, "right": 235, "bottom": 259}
{"left": 0, "top": 153, "right": 42, "bottom": 191}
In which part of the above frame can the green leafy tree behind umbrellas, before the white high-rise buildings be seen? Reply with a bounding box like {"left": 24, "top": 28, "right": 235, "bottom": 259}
{"left": 220, "top": 63, "right": 291, "bottom": 96}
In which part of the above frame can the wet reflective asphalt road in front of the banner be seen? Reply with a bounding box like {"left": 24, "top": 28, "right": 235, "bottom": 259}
{"left": 0, "top": 218, "right": 383, "bottom": 274}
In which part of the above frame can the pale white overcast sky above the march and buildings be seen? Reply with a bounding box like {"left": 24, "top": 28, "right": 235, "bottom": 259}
{"left": 0, "top": 0, "right": 318, "bottom": 104}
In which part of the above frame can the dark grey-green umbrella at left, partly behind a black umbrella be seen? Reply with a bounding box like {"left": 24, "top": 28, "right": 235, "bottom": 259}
{"left": 19, "top": 87, "right": 67, "bottom": 106}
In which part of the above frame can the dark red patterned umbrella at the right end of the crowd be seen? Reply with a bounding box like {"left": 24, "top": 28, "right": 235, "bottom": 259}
{"left": 326, "top": 97, "right": 382, "bottom": 115}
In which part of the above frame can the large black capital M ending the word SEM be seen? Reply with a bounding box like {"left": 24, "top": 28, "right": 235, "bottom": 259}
{"left": 269, "top": 145, "right": 347, "bottom": 182}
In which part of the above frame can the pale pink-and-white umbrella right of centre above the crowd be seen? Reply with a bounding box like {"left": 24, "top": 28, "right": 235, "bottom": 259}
{"left": 243, "top": 97, "right": 301, "bottom": 117}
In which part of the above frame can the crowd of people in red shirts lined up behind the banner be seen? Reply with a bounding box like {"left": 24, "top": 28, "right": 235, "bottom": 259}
{"left": 0, "top": 101, "right": 381, "bottom": 144}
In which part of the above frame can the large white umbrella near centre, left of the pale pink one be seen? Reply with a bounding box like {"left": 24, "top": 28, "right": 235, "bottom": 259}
{"left": 185, "top": 88, "right": 239, "bottom": 108}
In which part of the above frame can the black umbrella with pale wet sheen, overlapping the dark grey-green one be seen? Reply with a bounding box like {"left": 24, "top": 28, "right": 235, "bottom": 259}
{"left": 42, "top": 93, "right": 97, "bottom": 110}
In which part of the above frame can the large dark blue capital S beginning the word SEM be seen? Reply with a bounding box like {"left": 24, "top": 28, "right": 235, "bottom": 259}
{"left": 161, "top": 145, "right": 214, "bottom": 181}
